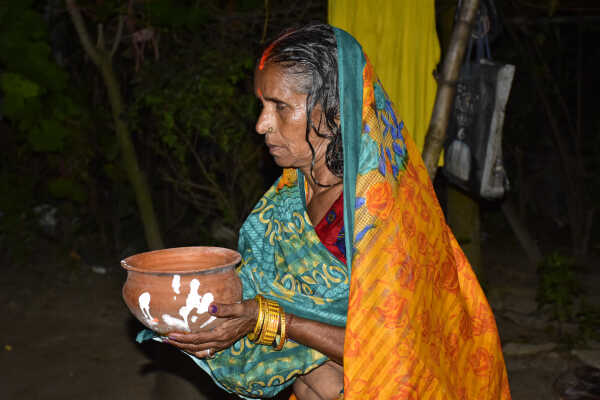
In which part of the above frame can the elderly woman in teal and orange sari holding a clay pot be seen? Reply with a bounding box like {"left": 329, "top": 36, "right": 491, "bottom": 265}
{"left": 168, "top": 25, "right": 510, "bottom": 400}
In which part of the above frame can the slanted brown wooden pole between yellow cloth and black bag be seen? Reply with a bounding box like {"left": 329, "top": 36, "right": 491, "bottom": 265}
{"left": 423, "top": 0, "right": 479, "bottom": 180}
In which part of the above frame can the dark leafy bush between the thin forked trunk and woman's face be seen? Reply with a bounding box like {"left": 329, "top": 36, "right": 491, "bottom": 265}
{"left": 130, "top": 43, "right": 264, "bottom": 245}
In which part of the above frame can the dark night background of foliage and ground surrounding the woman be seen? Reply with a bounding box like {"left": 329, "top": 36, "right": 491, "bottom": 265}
{"left": 0, "top": 0, "right": 600, "bottom": 399}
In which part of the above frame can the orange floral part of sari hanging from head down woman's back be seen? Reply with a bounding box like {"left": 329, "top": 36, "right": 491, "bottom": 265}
{"left": 336, "top": 30, "right": 510, "bottom": 400}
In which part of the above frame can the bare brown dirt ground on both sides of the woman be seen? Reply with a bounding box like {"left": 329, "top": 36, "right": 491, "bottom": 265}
{"left": 0, "top": 219, "right": 600, "bottom": 400}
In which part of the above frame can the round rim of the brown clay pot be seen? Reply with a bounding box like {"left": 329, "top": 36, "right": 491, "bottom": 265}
{"left": 121, "top": 246, "right": 242, "bottom": 275}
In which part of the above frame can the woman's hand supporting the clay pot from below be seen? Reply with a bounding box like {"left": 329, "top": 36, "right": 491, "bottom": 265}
{"left": 167, "top": 299, "right": 258, "bottom": 358}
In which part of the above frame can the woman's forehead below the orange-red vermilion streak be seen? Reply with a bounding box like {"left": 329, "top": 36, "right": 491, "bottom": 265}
{"left": 254, "top": 63, "right": 302, "bottom": 98}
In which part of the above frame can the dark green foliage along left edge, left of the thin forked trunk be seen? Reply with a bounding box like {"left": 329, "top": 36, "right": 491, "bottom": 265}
{"left": 0, "top": 0, "right": 102, "bottom": 263}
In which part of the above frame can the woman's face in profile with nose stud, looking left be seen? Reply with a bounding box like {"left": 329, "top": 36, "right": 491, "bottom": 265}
{"left": 254, "top": 63, "right": 327, "bottom": 168}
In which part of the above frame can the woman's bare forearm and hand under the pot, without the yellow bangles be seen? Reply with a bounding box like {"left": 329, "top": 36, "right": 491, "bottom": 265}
{"left": 168, "top": 299, "right": 345, "bottom": 365}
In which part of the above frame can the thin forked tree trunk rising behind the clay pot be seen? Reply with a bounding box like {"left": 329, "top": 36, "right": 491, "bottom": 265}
{"left": 66, "top": 0, "right": 164, "bottom": 250}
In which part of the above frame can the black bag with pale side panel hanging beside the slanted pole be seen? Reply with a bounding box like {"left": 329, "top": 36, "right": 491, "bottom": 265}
{"left": 442, "top": 1, "right": 515, "bottom": 199}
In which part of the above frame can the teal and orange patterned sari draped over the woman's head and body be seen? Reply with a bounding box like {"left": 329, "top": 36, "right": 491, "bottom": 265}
{"left": 192, "top": 28, "right": 510, "bottom": 400}
